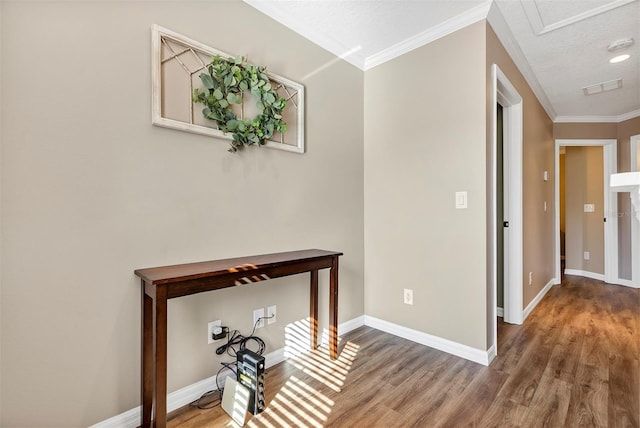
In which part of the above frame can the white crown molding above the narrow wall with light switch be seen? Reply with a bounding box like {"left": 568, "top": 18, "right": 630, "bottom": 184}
{"left": 362, "top": 0, "right": 493, "bottom": 71}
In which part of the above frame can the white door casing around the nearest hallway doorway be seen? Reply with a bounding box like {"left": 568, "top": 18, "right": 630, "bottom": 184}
{"left": 489, "top": 64, "right": 524, "bottom": 355}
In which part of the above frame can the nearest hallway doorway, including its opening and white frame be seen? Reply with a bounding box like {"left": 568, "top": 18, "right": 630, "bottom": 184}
{"left": 487, "top": 64, "right": 524, "bottom": 356}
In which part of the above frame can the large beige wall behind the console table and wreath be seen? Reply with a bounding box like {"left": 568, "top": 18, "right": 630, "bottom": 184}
{"left": 0, "top": 1, "right": 364, "bottom": 427}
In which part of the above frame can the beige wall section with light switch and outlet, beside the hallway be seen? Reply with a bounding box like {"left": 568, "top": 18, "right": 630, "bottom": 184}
{"left": 364, "top": 22, "right": 487, "bottom": 349}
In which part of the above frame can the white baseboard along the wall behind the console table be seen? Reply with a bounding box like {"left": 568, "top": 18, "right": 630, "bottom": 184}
{"left": 90, "top": 315, "right": 365, "bottom": 428}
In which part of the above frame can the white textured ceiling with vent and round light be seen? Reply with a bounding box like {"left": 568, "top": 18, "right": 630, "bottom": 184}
{"left": 244, "top": 0, "right": 640, "bottom": 122}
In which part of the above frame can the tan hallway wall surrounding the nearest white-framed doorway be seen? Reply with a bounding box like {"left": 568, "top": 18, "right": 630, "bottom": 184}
{"left": 486, "top": 24, "right": 555, "bottom": 318}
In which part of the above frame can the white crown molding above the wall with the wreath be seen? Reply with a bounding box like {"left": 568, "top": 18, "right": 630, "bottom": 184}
{"left": 243, "top": 0, "right": 365, "bottom": 70}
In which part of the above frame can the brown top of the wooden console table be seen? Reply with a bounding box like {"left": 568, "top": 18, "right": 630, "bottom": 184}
{"left": 135, "top": 250, "right": 343, "bottom": 284}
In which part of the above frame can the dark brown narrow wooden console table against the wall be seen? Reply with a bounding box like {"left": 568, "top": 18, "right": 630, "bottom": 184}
{"left": 135, "top": 250, "right": 342, "bottom": 428}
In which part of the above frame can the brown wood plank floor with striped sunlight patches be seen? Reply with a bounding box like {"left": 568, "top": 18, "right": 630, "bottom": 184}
{"left": 169, "top": 276, "right": 640, "bottom": 428}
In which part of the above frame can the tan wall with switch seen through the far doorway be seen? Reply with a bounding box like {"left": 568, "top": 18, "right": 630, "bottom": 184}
{"left": 565, "top": 147, "right": 605, "bottom": 275}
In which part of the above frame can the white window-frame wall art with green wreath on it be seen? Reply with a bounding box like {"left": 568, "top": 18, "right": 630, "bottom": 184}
{"left": 151, "top": 25, "right": 304, "bottom": 153}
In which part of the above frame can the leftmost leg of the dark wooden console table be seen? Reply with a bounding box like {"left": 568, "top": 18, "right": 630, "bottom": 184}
{"left": 140, "top": 280, "right": 154, "bottom": 428}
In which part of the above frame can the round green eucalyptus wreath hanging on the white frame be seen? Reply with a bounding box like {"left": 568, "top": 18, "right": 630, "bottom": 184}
{"left": 193, "top": 55, "right": 287, "bottom": 153}
